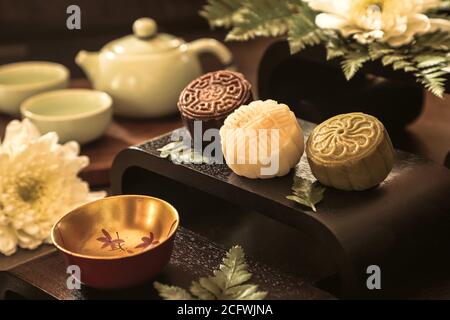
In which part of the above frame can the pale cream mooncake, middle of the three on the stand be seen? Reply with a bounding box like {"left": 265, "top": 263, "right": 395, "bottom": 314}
{"left": 220, "top": 100, "right": 304, "bottom": 179}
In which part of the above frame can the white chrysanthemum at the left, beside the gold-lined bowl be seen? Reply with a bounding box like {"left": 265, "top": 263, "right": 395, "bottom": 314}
{"left": 0, "top": 120, "right": 105, "bottom": 255}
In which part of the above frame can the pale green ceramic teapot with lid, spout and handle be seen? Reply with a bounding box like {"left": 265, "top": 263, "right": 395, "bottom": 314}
{"left": 75, "top": 18, "right": 232, "bottom": 117}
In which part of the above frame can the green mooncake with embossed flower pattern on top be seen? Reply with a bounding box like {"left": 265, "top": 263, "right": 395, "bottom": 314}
{"left": 306, "top": 112, "right": 394, "bottom": 190}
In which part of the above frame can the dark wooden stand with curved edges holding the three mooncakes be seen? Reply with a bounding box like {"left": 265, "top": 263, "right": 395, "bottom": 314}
{"left": 111, "top": 121, "right": 450, "bottom": 294}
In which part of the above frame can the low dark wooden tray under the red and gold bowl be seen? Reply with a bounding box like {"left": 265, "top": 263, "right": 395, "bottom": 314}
{"left": 0, "top": 227, "right": 333, "bottom": 300}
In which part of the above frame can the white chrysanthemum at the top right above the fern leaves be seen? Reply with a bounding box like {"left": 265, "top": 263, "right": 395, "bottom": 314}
{"left": 304, "top": 0, "right": 450, "bottom": 46}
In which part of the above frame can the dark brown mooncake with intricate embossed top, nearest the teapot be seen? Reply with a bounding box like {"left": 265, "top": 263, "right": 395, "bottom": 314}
{"left": 178, "top": 70, "right": 253, "bottom": 142}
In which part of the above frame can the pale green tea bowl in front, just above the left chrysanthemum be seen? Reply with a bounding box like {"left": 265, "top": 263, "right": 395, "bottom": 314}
{"left": 20, "top": 89, "right": 112, "bottom": 144}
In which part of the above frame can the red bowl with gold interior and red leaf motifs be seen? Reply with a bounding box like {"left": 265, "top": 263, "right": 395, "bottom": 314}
{"left": 52, "top": 195, "right": 179, "bottom": 289}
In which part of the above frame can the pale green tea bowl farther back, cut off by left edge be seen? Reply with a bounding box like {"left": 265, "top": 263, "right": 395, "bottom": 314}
{"left": 0, "top": 61, "right": 70, "bottom": 116}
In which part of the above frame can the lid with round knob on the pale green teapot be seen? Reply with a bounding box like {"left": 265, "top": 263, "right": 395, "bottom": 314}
{"left": 103, "top": 18, "right": 184, "bottom": 54}
